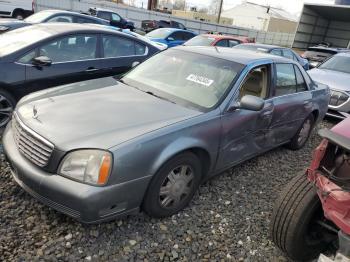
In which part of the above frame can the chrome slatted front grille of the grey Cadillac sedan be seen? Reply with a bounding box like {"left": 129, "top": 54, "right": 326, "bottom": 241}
{"left": 12, "top": 114, "right": 54, "bottom": 167}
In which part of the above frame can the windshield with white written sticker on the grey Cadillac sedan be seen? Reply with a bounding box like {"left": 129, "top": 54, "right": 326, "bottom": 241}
{"left": 122, "top": 50, "right": 244, "bottom": 110}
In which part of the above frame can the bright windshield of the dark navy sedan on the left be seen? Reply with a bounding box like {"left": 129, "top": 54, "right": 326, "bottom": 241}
{"left": 0, "top": 27, "right": 51, "bottom": 56}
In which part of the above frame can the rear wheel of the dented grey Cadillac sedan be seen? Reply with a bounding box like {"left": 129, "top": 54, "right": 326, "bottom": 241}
{"left": 286, "top": 114, "right": 315, "bottom": 150}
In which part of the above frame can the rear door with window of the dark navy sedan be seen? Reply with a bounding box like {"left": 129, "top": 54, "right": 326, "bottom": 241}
{"left": 101, "top": 34, "right": 149, "bottom": 76}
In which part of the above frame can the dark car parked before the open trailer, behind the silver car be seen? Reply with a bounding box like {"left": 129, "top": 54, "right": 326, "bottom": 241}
{"left": 301, "top": 45, "right": 350, "bottom": 68}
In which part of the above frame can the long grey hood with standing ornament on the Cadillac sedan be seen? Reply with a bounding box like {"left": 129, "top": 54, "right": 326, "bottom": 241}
{"left": 16, "top": 78, "right": 201, "bottom": 151}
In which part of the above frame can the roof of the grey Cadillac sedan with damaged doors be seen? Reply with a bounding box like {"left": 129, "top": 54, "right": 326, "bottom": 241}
{"left": 173, "top": 46, "right": 297, "bottom": 65}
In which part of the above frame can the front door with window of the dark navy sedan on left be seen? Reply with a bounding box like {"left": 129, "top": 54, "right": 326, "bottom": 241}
{"left": 20, "top": 34, "right": 100, "bottom": 91}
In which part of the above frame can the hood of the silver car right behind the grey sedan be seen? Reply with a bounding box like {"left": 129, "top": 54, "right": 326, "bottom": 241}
{"left": 308, "top": 68, "right": 350, "bottom": 91}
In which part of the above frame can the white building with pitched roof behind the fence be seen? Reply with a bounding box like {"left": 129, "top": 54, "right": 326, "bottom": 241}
{"left": 222, "top": 2, "right": 298, "bottom": 33}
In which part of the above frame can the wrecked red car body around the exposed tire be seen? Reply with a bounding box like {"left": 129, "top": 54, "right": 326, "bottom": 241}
{"left": 307, "top": 118, "right": 350, "bottom": 235}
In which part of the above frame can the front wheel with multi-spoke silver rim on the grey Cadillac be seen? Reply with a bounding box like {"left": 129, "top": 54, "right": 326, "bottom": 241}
{"left": 142, "top": 152, "right": 202, "bottom": 218}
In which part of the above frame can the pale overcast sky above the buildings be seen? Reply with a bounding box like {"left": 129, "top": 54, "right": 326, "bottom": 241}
{"left": 133, "top": 0, "right": 334, "bottom": 15}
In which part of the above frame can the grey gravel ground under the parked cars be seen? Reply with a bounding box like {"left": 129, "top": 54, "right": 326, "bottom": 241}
{"left": 0, "top": 119, "right": 332, "bottom": 261}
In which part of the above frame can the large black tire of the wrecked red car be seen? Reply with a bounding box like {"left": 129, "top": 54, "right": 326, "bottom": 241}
{"left": 270, "top": 174, "right": 331, "bottom": 261}
